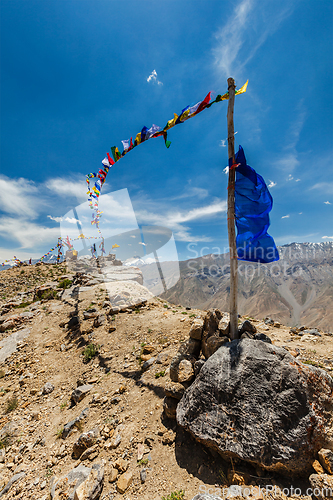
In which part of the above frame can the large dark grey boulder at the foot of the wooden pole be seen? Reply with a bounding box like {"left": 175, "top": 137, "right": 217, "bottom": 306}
{"left": 177, "top": 339, "right": 333, "bottom": 475}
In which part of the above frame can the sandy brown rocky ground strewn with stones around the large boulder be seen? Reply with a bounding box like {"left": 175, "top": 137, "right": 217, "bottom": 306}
{"left": 0, "top": 264, "right": 333, "bottom": 500}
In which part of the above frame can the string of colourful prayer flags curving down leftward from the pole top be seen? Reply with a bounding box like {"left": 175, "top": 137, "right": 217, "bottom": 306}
{"left": 86, "top": 81, "right": 248, "bottom": 229}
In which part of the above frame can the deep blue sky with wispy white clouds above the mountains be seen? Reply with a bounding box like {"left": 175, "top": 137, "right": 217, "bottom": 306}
{"left": 0, "top": 0, "right": 333, "bottom": 262}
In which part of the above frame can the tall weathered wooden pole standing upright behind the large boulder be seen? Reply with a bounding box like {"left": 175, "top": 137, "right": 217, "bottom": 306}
{"left": 227, "top": 78, "right": 238, "bottom": 340}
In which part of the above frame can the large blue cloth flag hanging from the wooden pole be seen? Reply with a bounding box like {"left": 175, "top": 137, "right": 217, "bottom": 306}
{"left": 235, "top": 146, "right": 279, "bottom": 263}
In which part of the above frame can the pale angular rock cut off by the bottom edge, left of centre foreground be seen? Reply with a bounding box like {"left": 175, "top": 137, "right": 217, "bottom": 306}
{"left": 50, "top": 464, "right": 104, "bottom": 500}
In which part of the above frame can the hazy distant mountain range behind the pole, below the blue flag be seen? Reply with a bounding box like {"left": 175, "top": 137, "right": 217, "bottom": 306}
{"left": 156, "top": 242, "right": 333, "bottom": 331}
